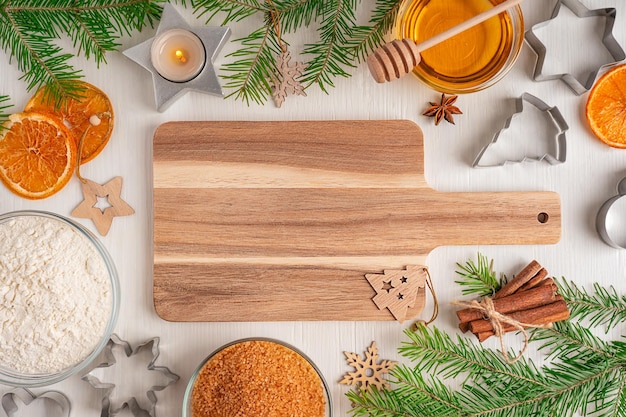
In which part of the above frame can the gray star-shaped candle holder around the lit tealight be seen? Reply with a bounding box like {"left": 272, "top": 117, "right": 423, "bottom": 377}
{"left": 123, "top": 4, "right": 230, "bottom": 112}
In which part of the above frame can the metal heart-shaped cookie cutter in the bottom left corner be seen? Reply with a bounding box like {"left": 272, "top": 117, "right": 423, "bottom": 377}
{"left": 2, "top": 388, "right": 72, "bottom": 417}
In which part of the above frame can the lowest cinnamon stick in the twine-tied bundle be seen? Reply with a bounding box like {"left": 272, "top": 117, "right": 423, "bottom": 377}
{"left": 469, "top": 295, "right": 569, "bottom": 334}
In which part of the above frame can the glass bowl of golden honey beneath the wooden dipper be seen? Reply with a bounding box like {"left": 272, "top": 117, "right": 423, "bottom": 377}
{"left": 395, "top": 0, "right": 524, "bottom": 94}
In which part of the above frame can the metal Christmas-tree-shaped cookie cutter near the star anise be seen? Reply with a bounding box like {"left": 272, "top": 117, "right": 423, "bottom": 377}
{"left": 472, "top": 93, "right": 569, "bottom": 168}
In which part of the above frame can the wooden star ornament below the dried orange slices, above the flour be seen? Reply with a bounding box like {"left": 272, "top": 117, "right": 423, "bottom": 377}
{"left": 72, "top": 177, "right": 135, "bottom": 236}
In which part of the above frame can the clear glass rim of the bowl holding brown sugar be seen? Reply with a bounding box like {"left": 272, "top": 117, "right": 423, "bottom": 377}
{"left": 182, "top": 337, "right": 333, "bottom": 417}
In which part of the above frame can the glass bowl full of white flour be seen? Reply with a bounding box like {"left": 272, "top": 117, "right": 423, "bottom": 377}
{"left": 0, "top": 211, "right": 120, "bottom": 387}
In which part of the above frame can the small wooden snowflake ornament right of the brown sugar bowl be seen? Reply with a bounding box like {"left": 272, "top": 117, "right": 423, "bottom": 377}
{"left": 339, "top": 342, "right": 398, "bottom": 390}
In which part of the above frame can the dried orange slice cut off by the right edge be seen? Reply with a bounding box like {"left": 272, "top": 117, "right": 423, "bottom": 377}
{"left": 585, "top": 65, "right": 626, "bottom": 148}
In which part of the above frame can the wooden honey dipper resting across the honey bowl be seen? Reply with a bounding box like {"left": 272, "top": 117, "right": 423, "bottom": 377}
{"left": 367, "top": 0, "right": 522, "bottom": 83}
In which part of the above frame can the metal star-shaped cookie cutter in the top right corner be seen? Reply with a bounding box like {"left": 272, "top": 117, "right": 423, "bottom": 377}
{"left": 525, "top": 0, "right": 626, "bottom": 95}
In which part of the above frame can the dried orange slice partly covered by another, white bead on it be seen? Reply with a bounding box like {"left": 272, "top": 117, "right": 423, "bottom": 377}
{"left": 24, "top": 81, "right": 113, "bottom": 164}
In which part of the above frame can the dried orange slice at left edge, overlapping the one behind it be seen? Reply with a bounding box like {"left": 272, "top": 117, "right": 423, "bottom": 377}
{"left": 0, "top": 113, "right": 76, "bottom": 200}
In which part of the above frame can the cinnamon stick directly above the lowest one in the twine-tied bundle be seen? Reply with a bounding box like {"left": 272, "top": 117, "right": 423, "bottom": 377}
{"left": 456, "top": 285, "right": 556, "bottom": 324}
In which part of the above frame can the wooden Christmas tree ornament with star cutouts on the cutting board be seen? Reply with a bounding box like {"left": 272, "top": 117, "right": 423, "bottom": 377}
{"left": 365, "top": 265, "right": 428, "bottom": 323}
